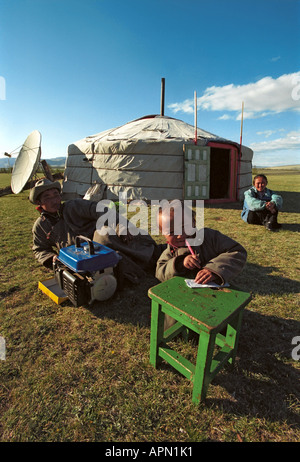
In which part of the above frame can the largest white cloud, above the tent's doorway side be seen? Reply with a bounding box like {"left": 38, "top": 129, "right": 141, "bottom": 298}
{"left": 168, "top": 72, "right": 300, "bottom": 119}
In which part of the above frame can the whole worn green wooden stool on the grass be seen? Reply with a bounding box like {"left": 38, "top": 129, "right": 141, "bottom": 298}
{"left": 148, "top": 277, "right": 251, "bottom": 403}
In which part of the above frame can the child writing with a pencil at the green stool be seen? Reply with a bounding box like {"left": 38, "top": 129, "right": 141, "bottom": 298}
{"left": 155, "top": 202, "right": 247, "bottom": 330}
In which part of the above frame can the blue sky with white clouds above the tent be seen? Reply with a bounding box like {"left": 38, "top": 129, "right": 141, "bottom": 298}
{"left": 0, "top": 0, "right": 300, "bottom": 166}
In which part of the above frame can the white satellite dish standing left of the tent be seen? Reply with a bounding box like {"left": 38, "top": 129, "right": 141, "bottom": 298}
{"left": 11, "top": 130, "right": 41, "bottom": 194}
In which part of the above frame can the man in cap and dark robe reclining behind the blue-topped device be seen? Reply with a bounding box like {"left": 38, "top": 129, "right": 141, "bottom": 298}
{"left": 29, "top": 178, "right": 165, "bottom": 282}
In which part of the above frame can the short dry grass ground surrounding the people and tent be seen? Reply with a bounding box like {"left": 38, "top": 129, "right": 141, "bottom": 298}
{"left": 0, "top": 171, "right": 300, "bottom": 442}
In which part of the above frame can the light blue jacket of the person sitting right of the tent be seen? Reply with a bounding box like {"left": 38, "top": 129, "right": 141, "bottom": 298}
{"left": 241, "top": 186, "right": 282, "bottom": 223}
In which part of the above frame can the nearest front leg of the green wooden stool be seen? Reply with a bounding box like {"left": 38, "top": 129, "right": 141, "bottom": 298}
{"left": 192, "top": 332, "right": 216, "bottom": 404}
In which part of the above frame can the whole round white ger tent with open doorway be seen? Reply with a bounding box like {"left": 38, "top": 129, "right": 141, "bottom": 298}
{"left": 63, "top": 115, "right": 253, "bottom": 202}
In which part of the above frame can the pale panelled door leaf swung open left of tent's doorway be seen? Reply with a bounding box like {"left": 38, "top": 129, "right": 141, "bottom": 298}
{"left": 183, "top": 145, "right": 211, "bottom": 199}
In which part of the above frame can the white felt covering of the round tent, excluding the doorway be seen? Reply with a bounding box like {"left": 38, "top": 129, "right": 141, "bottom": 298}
{"left": 63, "top": 116, "right": 253, "bottom": 200}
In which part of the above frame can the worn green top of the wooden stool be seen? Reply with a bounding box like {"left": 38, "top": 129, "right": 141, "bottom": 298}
{"left": 148, "top": 276, "right": 251, "bottom": 330}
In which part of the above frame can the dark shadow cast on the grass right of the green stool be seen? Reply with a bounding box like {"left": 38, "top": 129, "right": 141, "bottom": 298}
{"left": 206, "top": 309, "right": 300, "bottom": 430}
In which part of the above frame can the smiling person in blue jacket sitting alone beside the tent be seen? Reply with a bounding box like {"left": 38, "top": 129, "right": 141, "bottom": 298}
{"left": 241, "top": 174, "right": 282, "bottom": 231}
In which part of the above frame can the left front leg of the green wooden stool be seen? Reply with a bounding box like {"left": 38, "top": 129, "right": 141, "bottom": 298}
{"left": 150, "top": 300, "right": 164, "bottom": 367}
